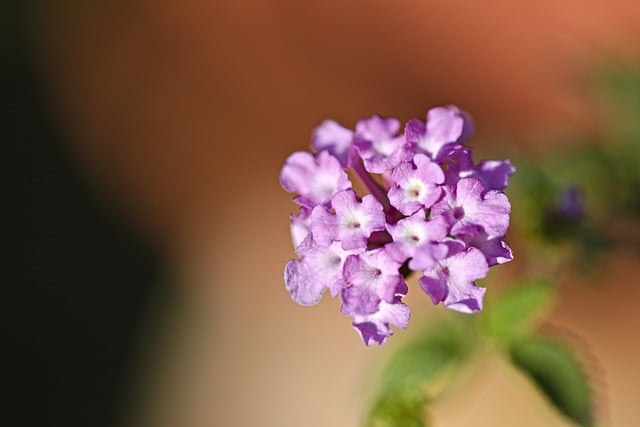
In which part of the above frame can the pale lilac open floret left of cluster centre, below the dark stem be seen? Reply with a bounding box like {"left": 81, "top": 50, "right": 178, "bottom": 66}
{"left": 311, "top": 190, "right": 385, "bottom": 250}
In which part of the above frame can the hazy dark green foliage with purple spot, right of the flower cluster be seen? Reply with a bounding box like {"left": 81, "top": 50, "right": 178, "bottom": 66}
{"left": 509, "top": 67, "right": 640, "bottom": 269}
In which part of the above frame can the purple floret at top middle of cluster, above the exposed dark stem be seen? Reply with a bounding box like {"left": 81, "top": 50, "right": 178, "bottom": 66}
{"left": 353, "top": 116, "right": 410, "bottom": 173}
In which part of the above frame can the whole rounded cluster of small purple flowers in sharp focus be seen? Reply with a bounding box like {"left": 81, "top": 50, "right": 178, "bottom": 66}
{"left": 280, "top": 106, "right": 515, "bottom": 345}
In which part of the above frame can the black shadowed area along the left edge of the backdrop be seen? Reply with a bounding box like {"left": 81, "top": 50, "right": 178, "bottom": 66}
{"left": 0, "top": 1, "right": 159, "bottom": 427}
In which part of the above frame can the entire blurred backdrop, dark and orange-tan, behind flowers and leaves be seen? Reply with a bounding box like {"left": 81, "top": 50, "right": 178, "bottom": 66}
{"left": 7, "top": 0, "right": 640, "bottom": 427}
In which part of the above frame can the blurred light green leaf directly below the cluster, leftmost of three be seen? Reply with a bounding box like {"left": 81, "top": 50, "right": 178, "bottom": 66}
{"left": 366, "top": 323, "right": 474, "bottom": 427}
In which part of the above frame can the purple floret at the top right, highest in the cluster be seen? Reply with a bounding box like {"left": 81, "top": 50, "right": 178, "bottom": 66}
{"left": 405, "top": 106, "right": 468, "bottom": 159}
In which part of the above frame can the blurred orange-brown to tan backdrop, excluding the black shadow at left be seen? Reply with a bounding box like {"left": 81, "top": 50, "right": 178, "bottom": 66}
{"left": 13, "top": 0, "right": 640, "bottom": 427}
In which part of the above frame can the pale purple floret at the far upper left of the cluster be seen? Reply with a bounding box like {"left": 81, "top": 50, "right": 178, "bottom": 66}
{"left": 280, "top": 151, "right": 351, "bottom": 208}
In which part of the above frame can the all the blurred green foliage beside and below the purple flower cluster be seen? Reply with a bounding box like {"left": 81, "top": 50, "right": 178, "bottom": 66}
{"left": 366, "top": 67, "right": 640, "bottom": 427}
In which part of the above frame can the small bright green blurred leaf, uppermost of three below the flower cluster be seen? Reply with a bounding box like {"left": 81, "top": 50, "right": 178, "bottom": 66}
{"left": 480, "top": 280, "right": 553, "bottom": 343}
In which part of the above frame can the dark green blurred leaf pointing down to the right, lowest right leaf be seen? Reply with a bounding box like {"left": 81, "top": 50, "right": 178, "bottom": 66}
{"left": 510, "top": 337, "right": 594, "bottom": 427}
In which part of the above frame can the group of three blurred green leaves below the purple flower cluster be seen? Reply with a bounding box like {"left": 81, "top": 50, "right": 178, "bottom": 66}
{"left": 366, "top": 280, "right": 593, "bottom": 427}
